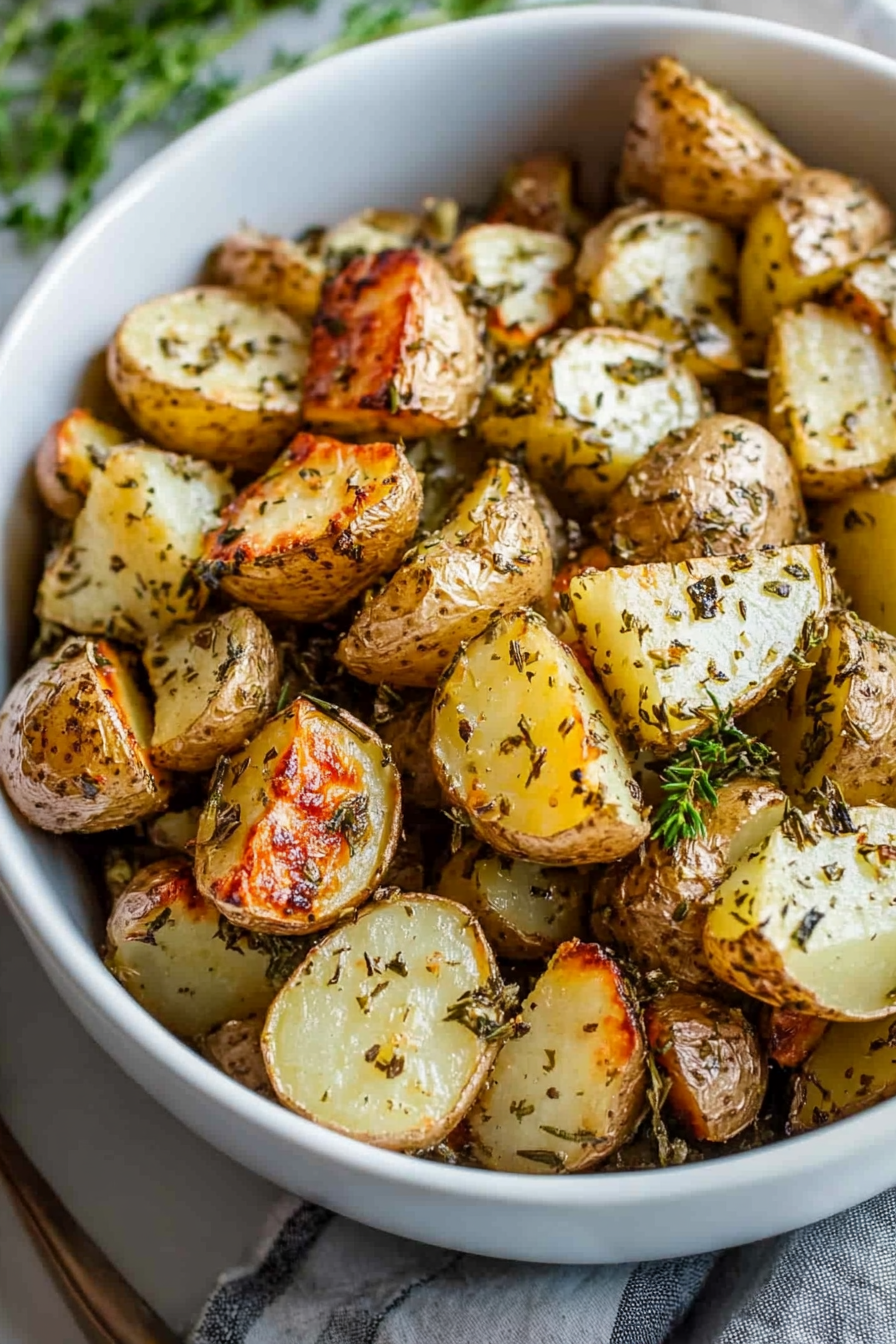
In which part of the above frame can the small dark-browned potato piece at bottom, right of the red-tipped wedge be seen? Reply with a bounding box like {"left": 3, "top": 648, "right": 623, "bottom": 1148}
{"left": 643, "top": 993, "right": 768, "bottom": 1144}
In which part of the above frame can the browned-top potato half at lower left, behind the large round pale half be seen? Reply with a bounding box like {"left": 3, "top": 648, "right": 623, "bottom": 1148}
{"left": 105, "top": 859, "right": 291, "bottom": 1039}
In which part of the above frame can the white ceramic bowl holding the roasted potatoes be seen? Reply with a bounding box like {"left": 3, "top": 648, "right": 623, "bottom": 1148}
{"left": 0, "top": 7, "right": 896, "bottom": 1262}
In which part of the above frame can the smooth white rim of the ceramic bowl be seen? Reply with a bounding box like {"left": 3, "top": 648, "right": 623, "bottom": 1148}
{"left": 0, "top": 4, "right": 896, "bottom": 1210}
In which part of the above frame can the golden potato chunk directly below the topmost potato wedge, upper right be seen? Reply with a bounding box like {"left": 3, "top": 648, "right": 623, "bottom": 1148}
{"left": 740, "top": 168, "right": 893, "bottom": 358}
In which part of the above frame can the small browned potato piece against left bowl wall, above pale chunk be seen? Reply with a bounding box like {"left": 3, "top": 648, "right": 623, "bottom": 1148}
{"left": 34, "top": 409, "right": 128, "bottom": 517}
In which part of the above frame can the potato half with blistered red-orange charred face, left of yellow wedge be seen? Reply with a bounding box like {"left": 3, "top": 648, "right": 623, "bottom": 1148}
{"left": 196, "top": 696, "right": 402, "bottom": 934}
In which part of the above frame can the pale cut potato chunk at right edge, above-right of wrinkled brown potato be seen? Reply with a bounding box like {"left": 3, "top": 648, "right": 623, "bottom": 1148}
{"left": 768, "top": 304, "right": 896, "bottom": 499}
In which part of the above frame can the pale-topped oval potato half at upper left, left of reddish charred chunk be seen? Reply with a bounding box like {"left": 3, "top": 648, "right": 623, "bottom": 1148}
{"left": 107, "top": 285, "right": 308, "bottom": 470}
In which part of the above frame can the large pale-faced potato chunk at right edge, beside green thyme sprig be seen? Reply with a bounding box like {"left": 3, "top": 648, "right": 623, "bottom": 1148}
{"left": 703, "top": 801, "right": 896, "bottom": 1021}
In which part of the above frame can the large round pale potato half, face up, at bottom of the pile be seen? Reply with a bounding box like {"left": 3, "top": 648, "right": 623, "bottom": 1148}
{"left": 262, "top": 895, "right": 500, "bottom": 1149}
